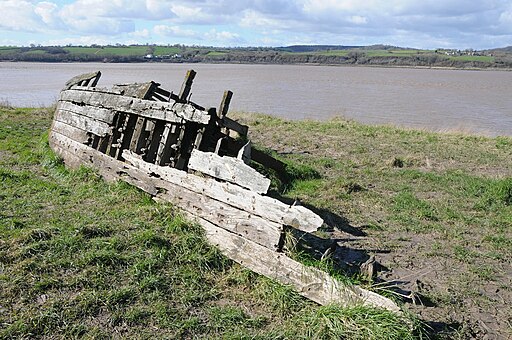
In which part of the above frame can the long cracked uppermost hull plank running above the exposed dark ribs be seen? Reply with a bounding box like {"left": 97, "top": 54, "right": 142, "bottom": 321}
{"left": 60, "top": 88, "right": 210, "bottom": 124}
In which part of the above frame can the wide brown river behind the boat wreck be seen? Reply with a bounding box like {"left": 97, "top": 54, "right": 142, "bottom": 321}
{"left": 0, "top": 62, "right": 512, "bottom": 136}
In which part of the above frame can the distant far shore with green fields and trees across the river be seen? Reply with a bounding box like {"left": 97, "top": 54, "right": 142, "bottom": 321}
{"left": 0, "top": 45, "right": 512, "bottom": 70}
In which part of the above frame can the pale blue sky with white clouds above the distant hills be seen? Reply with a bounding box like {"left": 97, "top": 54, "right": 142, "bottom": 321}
{"left": 0, "top": 0, "right": 512, "bottom": 49}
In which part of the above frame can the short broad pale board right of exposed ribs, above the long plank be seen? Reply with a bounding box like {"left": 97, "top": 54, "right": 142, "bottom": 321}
{"left": 188, "top": 149, "right": 270, "bottom": 193}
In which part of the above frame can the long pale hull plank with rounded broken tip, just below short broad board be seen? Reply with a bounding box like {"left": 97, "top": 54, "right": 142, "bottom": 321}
{"left": 123, "top": 150, "right": 323, "bottom": 232}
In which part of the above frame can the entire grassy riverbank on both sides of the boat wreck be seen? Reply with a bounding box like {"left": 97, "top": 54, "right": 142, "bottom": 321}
{"left": 0, "top": 108, "right": 512, "bottom": 339}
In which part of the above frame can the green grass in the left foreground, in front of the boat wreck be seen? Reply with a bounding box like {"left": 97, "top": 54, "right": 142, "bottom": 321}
{"left": 0, "top": 107, "right": 424, "bottom": 339}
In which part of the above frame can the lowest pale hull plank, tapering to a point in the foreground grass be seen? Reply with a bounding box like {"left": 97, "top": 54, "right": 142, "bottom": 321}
{"left": 188, "top": 215, "right": 400, "bottom": 313}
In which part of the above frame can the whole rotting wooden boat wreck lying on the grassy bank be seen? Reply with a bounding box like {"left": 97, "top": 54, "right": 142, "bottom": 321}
{"left": 49, "top": 70, "right": 399, "bottom": 312}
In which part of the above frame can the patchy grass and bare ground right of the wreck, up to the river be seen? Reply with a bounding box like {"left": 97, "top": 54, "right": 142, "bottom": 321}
{"left": 236, "top": 115, "right": 512, "bottom": 338}
